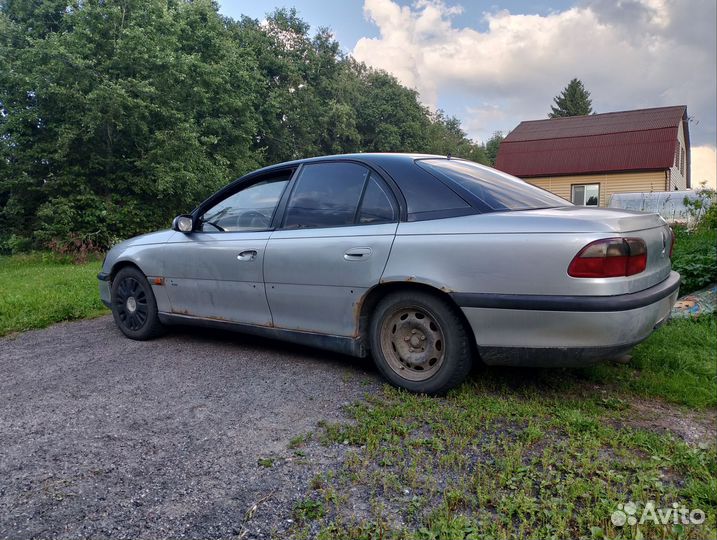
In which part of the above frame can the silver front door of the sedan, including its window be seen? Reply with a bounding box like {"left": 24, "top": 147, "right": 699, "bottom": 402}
{"left": 165, "top": 172, "right": 290, "bottom": 326}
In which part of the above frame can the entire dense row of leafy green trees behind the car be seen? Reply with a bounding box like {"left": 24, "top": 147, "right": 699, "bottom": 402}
{"left": 0, "top": 0, "right": 487, "bottom": 252}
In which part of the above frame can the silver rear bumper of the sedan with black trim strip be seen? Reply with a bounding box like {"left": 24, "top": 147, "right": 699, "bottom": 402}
{"left": 453, "top": 272, "right": 680, "bottom": 366}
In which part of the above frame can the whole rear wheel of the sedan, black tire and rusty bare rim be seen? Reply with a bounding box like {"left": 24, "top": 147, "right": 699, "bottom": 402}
{"left": 370, "top": 291, "right": 473, "bottom": 394}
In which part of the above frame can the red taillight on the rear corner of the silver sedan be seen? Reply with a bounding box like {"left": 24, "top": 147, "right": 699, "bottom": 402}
{"left": 568, "top": 238, "right": 647, "bottom": 278}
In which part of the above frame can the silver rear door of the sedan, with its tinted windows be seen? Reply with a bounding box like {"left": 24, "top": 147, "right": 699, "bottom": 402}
{"left": 264, "top": 162, "right": 398, "bottom": 336}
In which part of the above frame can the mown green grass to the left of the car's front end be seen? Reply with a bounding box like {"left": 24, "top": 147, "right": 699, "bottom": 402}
{"left": 0, "top": 254, "right": 108, "bottom": 336}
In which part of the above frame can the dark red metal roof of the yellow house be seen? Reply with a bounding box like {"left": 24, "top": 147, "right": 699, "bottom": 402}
{"left": 495, "top": 106, "right": 689, "bottom": 178}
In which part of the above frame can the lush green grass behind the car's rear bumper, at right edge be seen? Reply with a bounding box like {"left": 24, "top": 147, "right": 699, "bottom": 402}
{"left": 586, "top": 315, "right": 717, "bottom": 408}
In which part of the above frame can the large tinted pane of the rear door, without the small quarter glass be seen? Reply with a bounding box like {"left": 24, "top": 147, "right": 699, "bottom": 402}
{"left": 284, "top": 163, "right": 369, "bottom": 229}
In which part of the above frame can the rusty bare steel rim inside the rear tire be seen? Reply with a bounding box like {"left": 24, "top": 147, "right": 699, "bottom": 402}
{"left": 381, "top": 307, "right": 446, "bottom": 381}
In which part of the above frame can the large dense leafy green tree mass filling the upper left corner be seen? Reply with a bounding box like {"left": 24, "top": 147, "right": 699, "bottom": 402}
{"left": 0, "top": 0, "right": 259, "bottom": 248}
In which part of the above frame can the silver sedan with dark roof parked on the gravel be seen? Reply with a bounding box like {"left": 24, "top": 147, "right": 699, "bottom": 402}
{"left": 98, "top": 154, "right": 680, "bottom": 393}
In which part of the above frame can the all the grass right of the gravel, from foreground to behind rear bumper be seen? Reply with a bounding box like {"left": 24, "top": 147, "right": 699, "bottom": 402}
{"left": 292, "top": 316, "right": 717, "bottom": 540}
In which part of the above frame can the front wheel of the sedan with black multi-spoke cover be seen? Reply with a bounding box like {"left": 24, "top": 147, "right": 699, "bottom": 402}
{"left": 112, "top": 266, "right": 164, "bottom": 341}
